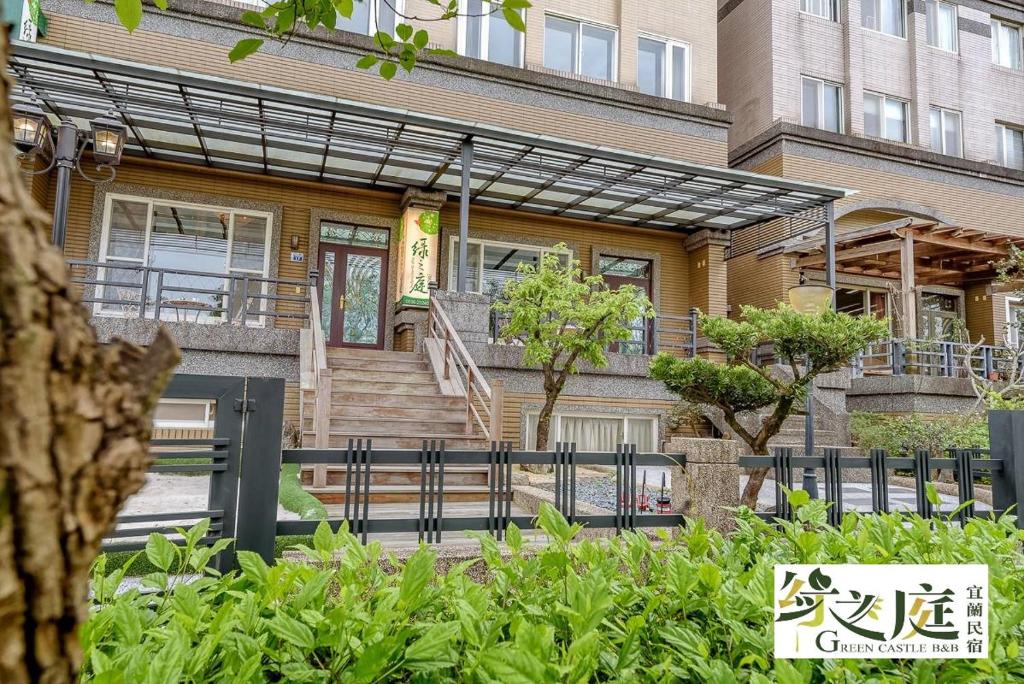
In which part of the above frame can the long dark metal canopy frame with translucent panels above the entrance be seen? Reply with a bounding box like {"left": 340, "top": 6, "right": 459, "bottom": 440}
{"left": 10, "top": 43, "right": 849, "bottom": 231}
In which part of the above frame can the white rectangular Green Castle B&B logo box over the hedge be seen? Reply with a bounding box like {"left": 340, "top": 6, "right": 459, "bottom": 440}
{"left": 774, "top": 565, "right": 988, "bottom": 658}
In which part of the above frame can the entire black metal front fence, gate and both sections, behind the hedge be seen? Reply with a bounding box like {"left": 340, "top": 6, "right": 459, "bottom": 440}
{"left": 114, "top": 375, "right": 1024, "bottom": 570}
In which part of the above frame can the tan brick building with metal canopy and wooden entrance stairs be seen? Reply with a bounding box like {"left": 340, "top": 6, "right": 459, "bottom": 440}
{"left": 11, "top": 0, "right": 845, "bottom": 485}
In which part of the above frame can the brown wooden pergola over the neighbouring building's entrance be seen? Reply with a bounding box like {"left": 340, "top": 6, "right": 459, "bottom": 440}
{"left": 785, "top": 218, "right": 1024, "bottom": 336}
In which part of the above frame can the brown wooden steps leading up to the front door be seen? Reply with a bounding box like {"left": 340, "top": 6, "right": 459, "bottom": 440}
{"left": 301, "top": 348, "right": 488, "bottom": 504}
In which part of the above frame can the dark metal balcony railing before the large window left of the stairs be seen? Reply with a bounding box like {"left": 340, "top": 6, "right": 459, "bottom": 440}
{"left": 68, "top": 259, "right": 309, "bottom": 328}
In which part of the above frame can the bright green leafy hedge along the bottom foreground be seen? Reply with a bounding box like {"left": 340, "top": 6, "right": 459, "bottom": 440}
{"left": 82, "top": 502, "right": 1024, "bottom": 683}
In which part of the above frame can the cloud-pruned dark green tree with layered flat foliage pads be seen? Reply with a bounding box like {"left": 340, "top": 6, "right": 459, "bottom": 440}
{"left": 650, "top": 304, "right": 889, "bottom": 508}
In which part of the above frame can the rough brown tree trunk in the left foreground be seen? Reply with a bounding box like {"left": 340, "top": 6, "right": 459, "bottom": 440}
{"left": 0, "top": 33, "right": 178, "bottom": 684}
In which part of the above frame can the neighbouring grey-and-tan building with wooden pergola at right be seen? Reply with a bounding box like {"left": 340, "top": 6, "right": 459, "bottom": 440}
{"left": 718, "top": 0, "right": 1024, "bottom": 343}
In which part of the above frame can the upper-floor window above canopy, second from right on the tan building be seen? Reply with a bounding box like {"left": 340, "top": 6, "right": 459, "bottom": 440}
{"left": 544, "top": 14, "right": 615, "bottom": 81}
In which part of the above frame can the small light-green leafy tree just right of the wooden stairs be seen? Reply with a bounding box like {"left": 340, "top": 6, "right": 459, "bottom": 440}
{"left": 494, "top": 245, "right": 654, "bottom": 452}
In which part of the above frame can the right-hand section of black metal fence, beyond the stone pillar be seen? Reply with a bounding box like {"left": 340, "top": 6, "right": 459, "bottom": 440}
{"left": 739, "top": 411, "right": 1024, "bottom": 527}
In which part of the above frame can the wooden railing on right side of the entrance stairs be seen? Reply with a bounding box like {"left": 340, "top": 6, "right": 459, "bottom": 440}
{"left": 426, "top": 298, "right": 505, "bottom": 441}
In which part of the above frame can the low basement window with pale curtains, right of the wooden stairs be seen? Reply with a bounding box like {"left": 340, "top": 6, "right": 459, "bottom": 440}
{"left": 525, "top": 413, "right": 657, "bottom": 454}
